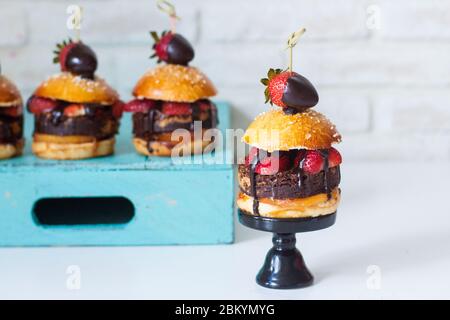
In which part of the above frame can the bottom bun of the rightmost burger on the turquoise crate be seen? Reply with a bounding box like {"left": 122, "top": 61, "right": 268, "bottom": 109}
{"left": 133, "top": 138, "right": 212, "bottom": 157}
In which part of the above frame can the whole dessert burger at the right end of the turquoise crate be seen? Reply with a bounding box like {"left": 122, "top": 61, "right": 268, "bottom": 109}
{"left": 124, "top": 31, "right": 217, "bottom": 156}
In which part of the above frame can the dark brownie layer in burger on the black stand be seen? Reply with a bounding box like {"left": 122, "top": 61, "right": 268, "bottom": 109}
{"left": 238, "top": 164, "right": 341, "bottom": 199}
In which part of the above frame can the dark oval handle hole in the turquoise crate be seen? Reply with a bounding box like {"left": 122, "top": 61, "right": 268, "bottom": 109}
{"left": 32, "top": 197, "right": 135, "bottom": 226}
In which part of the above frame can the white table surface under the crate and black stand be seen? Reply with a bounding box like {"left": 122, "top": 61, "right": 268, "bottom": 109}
{"left": 0, "top": 163, "right": 450, "bottom": 299}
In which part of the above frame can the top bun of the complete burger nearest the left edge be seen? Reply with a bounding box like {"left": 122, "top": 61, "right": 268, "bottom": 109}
{"left": 34, "top": 72, "right": 119, "bottom": 105}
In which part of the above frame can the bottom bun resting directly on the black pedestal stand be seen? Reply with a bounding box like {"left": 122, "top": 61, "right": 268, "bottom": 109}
{"left": 237, "top": 188, "right": 341, "bottom": 218}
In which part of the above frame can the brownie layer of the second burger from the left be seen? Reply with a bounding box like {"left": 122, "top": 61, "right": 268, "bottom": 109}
{"left": 34, "top": 106, "right": 119, "bottom": 139}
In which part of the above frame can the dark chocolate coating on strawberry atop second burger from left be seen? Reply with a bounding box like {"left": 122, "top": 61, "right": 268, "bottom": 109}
{"left": 66, "top": 43, "right": 97, "bottom": 79}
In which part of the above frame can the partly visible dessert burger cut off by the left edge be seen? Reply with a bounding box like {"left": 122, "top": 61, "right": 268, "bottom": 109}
{"left": 0, "top": 70, "right": 24, "bottom": 160}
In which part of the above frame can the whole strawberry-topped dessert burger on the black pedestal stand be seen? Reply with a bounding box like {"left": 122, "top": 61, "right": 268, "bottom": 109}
{"left": 237, "top": 69, "right": 342, "bottom": 218}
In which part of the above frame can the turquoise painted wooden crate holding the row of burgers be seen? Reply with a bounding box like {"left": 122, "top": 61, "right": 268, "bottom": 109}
{"left": 0, "top": 102, "right": 234, "bottom": 246}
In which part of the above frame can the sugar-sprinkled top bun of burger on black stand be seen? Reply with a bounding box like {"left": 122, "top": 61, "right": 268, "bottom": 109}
{"left": 242, "top": 109, "right": 341, "bottom": 152}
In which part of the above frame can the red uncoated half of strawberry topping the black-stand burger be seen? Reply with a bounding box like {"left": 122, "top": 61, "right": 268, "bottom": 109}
{"left": 261, "top": 69, "right": 295, "bottom": 108}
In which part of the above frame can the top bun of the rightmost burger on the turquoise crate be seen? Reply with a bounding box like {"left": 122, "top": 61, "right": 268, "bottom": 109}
{"left": 133, "top": 64, "right": 217, "bottom": 102}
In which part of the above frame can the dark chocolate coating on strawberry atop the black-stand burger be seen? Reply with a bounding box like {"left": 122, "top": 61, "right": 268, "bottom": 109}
{"left": 281, "top": 73, "right": 319, "bottom": 112}
